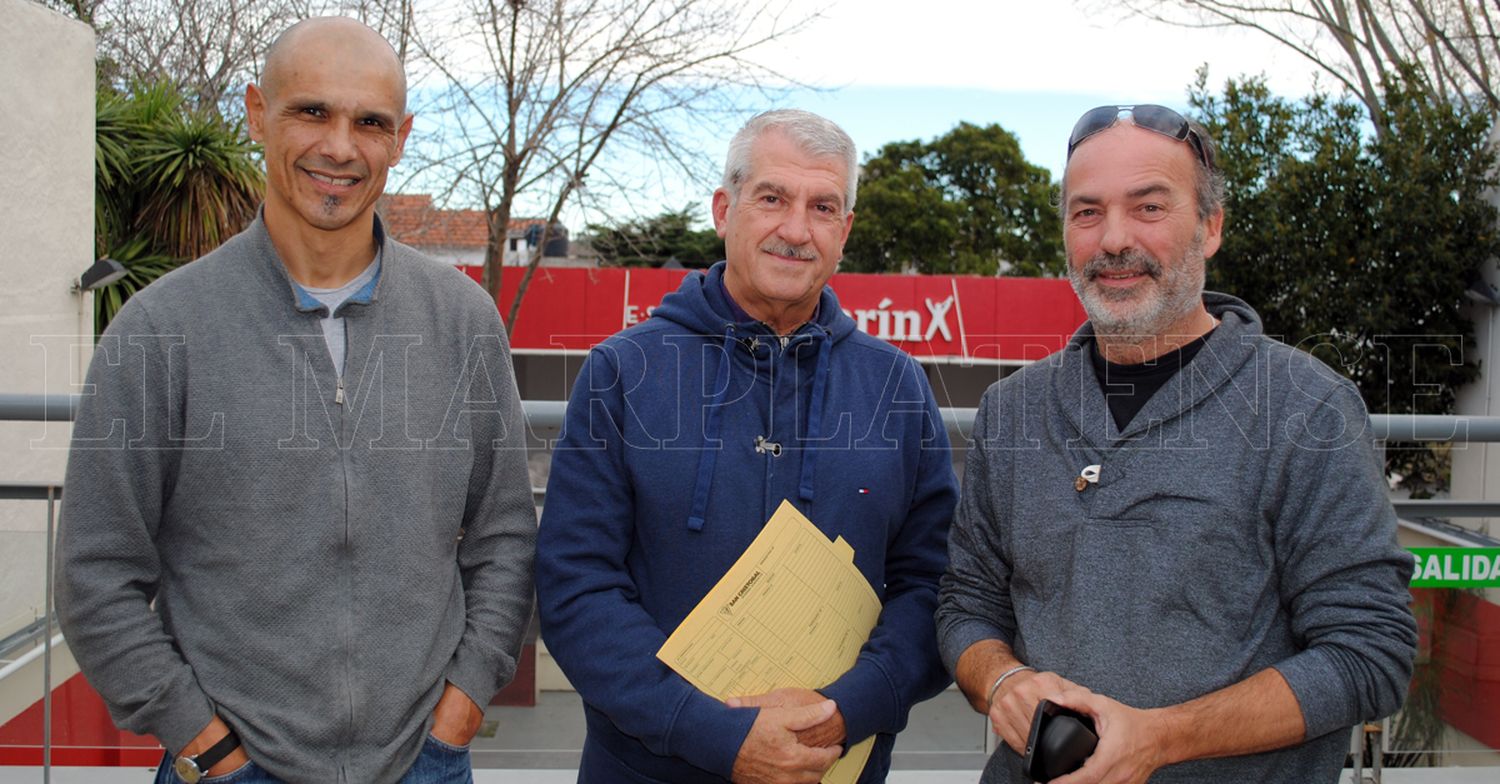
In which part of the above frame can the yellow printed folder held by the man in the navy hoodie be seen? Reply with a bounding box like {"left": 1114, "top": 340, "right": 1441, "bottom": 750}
{"left": 657, "top": 501, "right": 881, "bottom": 784}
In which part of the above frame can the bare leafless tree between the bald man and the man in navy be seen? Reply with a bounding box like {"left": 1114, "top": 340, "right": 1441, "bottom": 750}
{"left": 408, "top": 0, "right": 812, "bottom": 327}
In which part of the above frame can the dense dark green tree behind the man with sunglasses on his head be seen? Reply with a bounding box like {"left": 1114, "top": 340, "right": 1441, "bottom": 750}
{"left": 1190, "top": 73, "right": 1500, "bottom": 493}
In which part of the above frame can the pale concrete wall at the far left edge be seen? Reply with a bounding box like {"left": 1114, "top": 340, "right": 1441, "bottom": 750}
{"left": 0, "top": 0, "right": 95, "bottom": 656}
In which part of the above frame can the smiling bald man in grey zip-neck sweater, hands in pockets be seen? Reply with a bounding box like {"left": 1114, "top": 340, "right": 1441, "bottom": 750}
{"left": 57, "top": 18, "right": 536, "bottom": 784}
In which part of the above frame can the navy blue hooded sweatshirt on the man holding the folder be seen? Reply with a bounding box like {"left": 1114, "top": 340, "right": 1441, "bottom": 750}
{"left": 537, "top": 262, "right": 957, "bottom": 783}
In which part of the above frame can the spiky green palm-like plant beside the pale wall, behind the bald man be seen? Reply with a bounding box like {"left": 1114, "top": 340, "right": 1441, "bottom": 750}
{"left": 95, "top": 82, "right": 264, "bottom": 333}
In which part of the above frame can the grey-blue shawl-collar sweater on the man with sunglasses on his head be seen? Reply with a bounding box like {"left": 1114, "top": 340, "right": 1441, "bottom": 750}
{"left": 938, "top": 292, "right": 1418, "bottom": 784}
